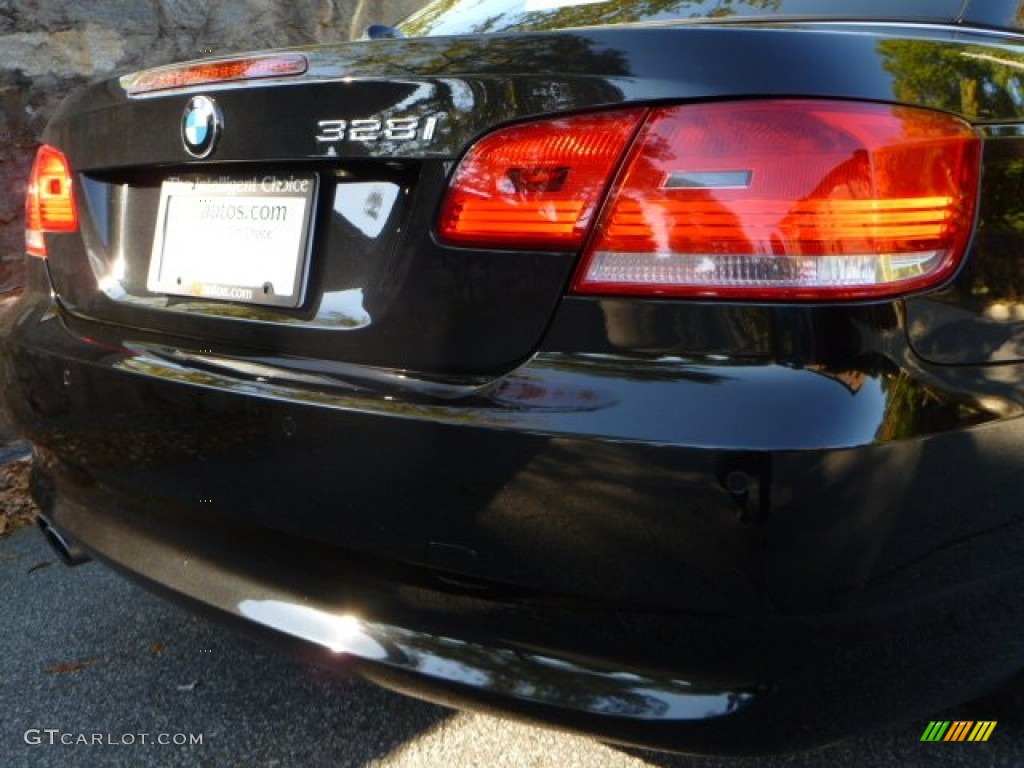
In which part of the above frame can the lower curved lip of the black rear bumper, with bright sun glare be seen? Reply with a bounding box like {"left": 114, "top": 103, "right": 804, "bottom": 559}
{"left": 32, "top": 479, "right": 1024, "bottom": 755}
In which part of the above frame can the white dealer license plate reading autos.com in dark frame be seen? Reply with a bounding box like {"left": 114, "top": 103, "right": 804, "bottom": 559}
{"left": 146, "top": 174, "right": 316, "bottom": 307}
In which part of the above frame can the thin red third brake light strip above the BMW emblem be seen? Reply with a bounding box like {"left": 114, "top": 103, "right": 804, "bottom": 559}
{"left": 121, "top": 53, "right": 309, "bottom": 96}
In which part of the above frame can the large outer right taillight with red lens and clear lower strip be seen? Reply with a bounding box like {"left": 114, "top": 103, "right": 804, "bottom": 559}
{"left": 573, "top": 100, "right": 981, "bottom": 299}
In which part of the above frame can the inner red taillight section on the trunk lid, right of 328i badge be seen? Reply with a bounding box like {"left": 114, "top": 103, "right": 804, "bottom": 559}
{"left": 438, "top": 110, "right": 645, "bottom": 250}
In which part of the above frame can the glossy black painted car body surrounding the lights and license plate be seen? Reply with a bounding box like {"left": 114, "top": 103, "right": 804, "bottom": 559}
{"left": 6, "top": 12, "right": 1024, "bottom": 752}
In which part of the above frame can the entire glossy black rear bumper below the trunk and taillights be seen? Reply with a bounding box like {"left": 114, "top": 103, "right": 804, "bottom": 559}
{"left": 3, "top": 278, "right": 1024, "bottom": 752}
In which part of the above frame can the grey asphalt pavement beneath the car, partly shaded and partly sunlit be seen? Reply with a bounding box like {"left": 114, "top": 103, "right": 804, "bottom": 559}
{"left": 0, "top": 529, "right": 1024, "bottom": 768}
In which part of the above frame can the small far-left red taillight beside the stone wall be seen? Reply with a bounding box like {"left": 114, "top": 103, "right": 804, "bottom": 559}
{"left": 25, "top": 144, "right": 78, "bottom": 258}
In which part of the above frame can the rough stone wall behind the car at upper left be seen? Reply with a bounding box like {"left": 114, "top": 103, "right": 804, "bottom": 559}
{"left": 0, "top": 0, "right": 425, "bottom": 291}
